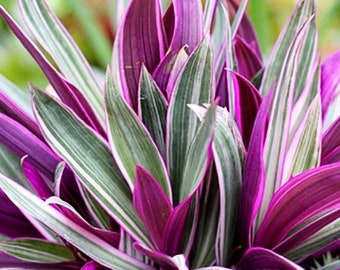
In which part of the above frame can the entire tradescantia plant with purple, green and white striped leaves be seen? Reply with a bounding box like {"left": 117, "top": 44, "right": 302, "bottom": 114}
{"left": 0, "top": 0, "right": 340, "bottom": 270}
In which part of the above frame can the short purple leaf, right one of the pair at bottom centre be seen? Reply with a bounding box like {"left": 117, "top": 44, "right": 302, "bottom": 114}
{"left": 163, "top": 194, "right": 194, "bottom": 256}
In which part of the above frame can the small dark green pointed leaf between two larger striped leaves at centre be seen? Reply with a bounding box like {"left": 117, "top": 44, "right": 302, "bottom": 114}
{"left": 139, "top": 66, "right": 168, "bottom": 157}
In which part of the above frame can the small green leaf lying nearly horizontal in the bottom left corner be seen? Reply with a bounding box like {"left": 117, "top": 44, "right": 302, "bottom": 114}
{"left": 0, "top": 238, "right": 76, "bottom": 263}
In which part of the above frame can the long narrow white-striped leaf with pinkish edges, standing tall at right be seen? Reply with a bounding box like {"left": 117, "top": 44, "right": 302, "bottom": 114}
{"left": 256, "top": 17, "right": 314, "bottom": 228}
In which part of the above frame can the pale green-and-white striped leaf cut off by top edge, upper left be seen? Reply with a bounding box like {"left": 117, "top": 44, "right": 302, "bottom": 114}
{"left": 19, "top": 0, "right": 105, "bottom": 123}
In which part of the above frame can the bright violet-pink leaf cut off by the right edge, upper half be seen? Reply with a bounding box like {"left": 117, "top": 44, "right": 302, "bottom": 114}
{"left": 321, "top": 50, "right": 340, "bottom": 119}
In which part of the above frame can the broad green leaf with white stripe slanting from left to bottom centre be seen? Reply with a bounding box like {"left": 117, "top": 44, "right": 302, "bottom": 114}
{"left": 31, "top": 87, "right": 152, "bottom": 249}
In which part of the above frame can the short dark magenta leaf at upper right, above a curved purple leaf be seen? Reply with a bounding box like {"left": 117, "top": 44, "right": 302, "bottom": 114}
{"left": 234, "top": 36, "right": 262, "bottom": 80}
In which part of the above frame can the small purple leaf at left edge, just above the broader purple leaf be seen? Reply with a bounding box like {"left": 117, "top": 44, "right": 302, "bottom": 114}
{"left": 0, "top": 90, "right": 44, "bottom": 140}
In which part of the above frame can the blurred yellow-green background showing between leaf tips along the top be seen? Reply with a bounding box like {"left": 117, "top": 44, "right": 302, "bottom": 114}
{"left": 0, "top": 0, "right": 340, "bottom": 88}
